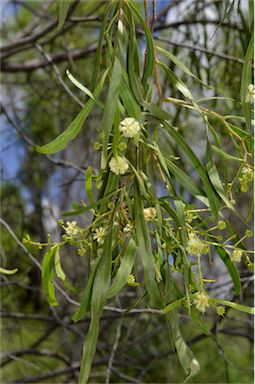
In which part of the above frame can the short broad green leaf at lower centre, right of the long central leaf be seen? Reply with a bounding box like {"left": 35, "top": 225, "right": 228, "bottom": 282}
{"left": 108, "top": 238, "right": 137, "bottom": 298}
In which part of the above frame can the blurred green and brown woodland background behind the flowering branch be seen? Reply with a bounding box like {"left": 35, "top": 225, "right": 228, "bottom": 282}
{"left": 0, "top": 0, "right": 253, "bottom": 383}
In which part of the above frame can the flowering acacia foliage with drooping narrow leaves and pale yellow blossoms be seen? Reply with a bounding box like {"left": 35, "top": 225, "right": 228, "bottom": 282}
{"left": 0, "top": 0, "right": 254, "bottom": 383}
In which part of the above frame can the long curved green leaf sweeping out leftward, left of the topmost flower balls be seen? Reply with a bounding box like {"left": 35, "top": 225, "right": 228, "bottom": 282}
{"left": 35, "top": 69, "right": 108, "bottom": 154}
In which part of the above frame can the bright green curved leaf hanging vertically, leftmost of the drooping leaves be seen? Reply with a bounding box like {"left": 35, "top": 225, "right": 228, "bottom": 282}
{"left": 42, "top": 246, "right": 58, "bottom": 307}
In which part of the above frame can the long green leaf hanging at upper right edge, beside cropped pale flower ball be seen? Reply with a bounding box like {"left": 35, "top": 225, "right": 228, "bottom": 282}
{"left": 241, "top": 35, "right": 254, "bottom": 130}
